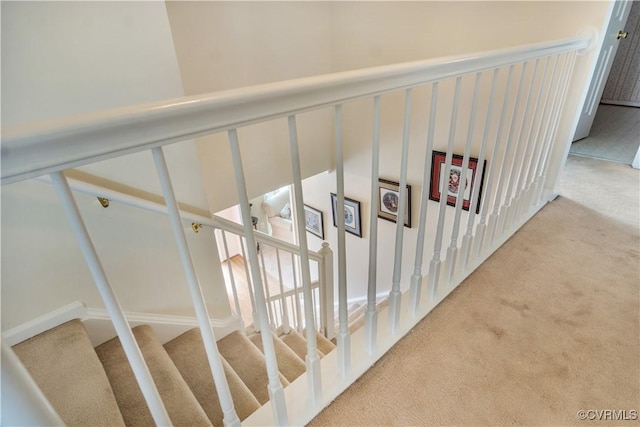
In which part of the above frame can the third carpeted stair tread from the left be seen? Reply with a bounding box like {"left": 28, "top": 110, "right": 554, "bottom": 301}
{"left": 164, "top": 328, "right": 261, "bottom": 426}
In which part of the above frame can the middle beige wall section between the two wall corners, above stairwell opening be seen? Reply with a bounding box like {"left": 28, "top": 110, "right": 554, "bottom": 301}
{"left": 167, "top": 2, "right": 333, "bottom": 212}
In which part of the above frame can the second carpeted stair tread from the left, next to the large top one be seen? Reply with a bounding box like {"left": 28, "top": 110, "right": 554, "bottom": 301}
{"left": 96, "top": 325, "right": 211, "bottom": 426}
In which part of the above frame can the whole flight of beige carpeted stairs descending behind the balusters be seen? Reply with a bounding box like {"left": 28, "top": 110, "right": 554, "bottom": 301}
{"left": 13, "top": 319, "right": 335, "bottom": 426}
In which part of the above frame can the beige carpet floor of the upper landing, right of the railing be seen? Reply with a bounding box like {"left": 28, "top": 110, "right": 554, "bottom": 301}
{"left": 310, "top": 157, "right": 640, "bottom": 426}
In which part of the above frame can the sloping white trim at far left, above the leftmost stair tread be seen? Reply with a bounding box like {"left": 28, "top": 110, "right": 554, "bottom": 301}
{"left": 2, "top": 301, "right": 87, "bottom": 346}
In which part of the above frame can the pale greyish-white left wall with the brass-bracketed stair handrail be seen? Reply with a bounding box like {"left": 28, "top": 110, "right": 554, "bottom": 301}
{"left": 2, "top": 2, "right": 229, "bottom": 330}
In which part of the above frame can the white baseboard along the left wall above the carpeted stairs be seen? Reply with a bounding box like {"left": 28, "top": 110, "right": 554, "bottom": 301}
{"left": 2, "top": 301, "right": 243, "bottom": 346}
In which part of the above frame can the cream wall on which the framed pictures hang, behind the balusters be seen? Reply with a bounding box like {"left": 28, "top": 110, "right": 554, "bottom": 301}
{"left": 304, "top": 1, "right": 609, "bottom": 299}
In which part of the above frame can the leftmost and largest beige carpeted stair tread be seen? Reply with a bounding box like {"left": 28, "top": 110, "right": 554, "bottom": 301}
{"left": 13, "top": 319, "right": 125, "bottom": 426}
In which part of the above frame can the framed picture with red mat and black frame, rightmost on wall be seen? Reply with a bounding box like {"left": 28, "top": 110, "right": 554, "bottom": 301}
{"left": 429, "top": 151, "right": 487, "bottom": 213}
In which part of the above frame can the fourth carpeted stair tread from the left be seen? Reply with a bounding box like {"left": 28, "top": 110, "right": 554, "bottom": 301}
{"left": 218, "top": 331, "right": 289, "bottom": 405}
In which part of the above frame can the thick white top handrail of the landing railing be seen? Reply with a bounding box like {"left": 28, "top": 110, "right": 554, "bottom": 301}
{"left": 1, "top": 38, "right": 590, "bottom": 184}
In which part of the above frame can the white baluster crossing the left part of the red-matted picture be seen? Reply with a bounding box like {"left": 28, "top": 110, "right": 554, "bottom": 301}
{"left": 429, "top": 77, "right": 462, "bottom": 301}
